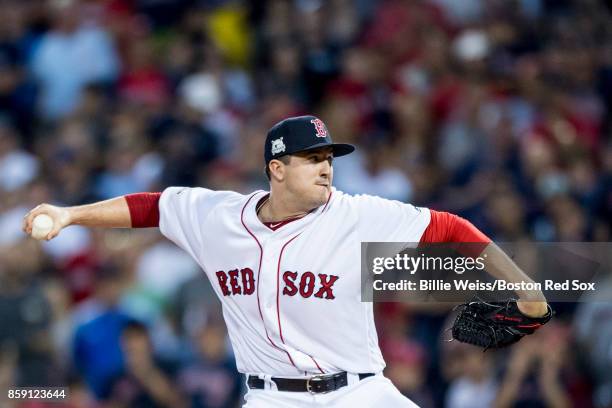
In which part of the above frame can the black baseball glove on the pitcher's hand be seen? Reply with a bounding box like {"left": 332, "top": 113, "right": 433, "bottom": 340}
{"left": 452, "top": 299, "right": 553, "bottom": 350}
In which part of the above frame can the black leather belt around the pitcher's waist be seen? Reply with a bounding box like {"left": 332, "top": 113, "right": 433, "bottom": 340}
{"left": 247, "top": 371, "right": 374, "bottom": 394}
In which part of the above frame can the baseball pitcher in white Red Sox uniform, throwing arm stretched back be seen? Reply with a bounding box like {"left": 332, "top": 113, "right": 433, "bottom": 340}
{"left": 23, "top": 116, "right": 551, "bottom": 408}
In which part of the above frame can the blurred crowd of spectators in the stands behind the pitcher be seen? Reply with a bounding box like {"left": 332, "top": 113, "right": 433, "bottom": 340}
{"left": 0, "top": 0, "right": 612, "bottom": 408}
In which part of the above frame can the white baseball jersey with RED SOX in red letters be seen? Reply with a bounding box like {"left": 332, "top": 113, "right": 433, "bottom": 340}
{"left": 159, "top": 187, "right": 430, "bottom": 377}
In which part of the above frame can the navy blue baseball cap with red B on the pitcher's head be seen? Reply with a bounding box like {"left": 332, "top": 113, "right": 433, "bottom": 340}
{"left": 264, "top": 116, "right": 355, "bottom": 165}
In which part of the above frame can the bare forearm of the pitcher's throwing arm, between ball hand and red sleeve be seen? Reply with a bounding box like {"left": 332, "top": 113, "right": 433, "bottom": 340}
{"left": 66, "top": 196, "right": 132, "bottom": 228}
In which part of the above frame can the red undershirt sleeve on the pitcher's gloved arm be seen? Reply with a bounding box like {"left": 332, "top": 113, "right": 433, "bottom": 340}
{"left": 419, "top": 210, "right": 492, "bottom": 256}
